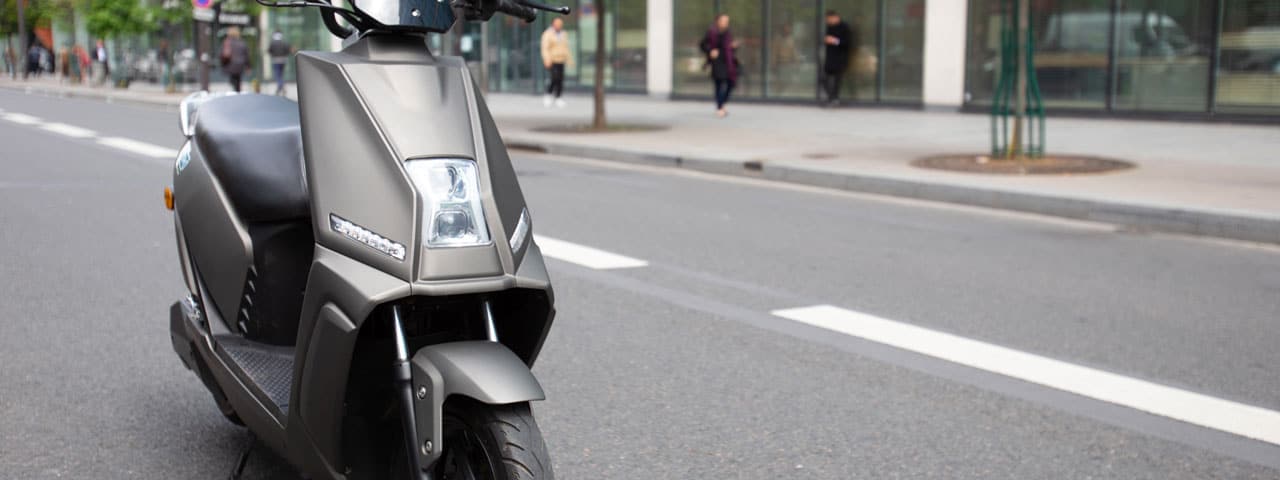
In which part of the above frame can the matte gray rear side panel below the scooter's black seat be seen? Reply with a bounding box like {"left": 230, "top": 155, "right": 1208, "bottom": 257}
{"left": 173, "top": 138, "right": 253, "bottom": 329}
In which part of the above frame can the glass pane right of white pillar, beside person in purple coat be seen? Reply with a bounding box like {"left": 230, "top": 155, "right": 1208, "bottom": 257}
{"left": 672, "top": 0, "right": 716, "bottom": 95}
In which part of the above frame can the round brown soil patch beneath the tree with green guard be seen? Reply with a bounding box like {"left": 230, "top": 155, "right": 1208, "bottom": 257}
{"left": 911, "top": 155, "right": 1138, "bottom": 175}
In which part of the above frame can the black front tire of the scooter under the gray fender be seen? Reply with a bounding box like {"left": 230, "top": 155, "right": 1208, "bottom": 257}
{"left": 436, "top": 401, "right": 556, "bottom": 480}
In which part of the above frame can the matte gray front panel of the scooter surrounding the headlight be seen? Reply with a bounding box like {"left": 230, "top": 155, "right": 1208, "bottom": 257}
{"left": 298, "top": 36, "right": 529, "bottom": 288}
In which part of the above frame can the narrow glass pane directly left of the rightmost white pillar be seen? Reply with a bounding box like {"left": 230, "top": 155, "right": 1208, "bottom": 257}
{"left": 881, "top": 0, "right": 924, "bottom": 101}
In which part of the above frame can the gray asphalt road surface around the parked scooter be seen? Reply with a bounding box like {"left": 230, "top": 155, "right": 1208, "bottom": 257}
{"left": 0, "top": 91, "right": 1280, "bottom": 479}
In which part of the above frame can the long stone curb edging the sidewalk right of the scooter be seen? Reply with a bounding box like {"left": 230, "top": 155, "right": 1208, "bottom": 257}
{"left": 507, "top": 136, "right": 1280, "bottom": 244}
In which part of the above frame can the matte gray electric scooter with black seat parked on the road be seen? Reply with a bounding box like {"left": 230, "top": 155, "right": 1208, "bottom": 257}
{"left": 165, "top": 0, "right": 568, "bottom": 480}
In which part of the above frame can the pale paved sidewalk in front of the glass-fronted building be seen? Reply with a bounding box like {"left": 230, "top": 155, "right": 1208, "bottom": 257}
{"left": 0, "top": 78, "right": 1280, "bottom": 243}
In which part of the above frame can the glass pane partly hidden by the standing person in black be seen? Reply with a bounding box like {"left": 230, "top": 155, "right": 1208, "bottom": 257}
{"left": 823, "top": 0, "right": 881, "bottom": 102}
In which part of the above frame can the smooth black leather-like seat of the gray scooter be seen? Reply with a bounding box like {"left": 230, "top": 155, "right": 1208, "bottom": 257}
{"left": 195, "top": 95, "right": 311, "bottom": 221}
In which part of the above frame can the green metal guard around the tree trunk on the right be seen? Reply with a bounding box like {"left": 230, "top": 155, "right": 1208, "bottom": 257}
{"left": 991, "top": 0, "right": 1044, "bottom": 160}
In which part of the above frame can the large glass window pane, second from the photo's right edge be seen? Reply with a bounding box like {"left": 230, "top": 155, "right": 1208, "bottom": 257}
{"left": 1112, "top": 0, "right": 1213, "bottom": 111}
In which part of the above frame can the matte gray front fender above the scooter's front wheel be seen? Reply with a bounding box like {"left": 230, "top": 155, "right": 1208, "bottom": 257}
{"left": 412, "top": 340, "right": 547, "bottom": 466}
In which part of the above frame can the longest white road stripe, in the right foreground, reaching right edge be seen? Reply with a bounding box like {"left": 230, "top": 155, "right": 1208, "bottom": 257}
{"left": 773, "top": 305, "right": 1280, "bottom": 444}
